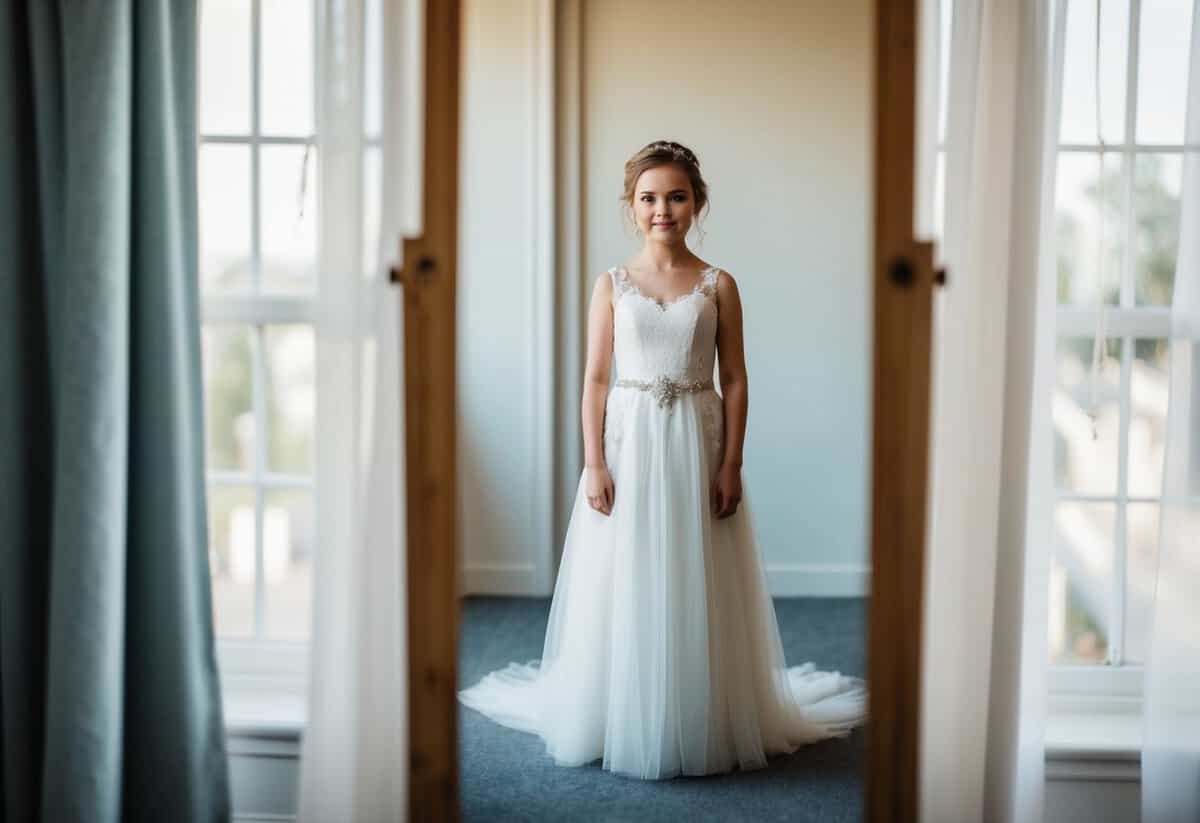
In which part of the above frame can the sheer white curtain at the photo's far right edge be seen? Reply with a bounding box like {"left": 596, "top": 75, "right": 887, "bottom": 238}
{"left": 1141, "top": 2, "right": 1200, "bottom": 823}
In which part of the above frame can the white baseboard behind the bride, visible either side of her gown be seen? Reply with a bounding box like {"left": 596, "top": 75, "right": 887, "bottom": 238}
{"left": 462, "top": 563, "right": 871, "bottom": 597}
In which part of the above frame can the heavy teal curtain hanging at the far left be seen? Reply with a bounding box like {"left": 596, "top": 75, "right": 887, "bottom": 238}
{"left": 0, "top": 0, "right": 229, "bottom": 823}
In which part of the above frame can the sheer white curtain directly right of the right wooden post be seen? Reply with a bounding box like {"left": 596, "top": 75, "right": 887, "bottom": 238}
{"left": 918, "top": 0, "right": 1062, "bottom": 823}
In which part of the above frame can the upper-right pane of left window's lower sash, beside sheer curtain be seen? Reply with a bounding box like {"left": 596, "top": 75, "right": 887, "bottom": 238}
{"left": 264, "top": 325, "right": 316, "bottom": 474}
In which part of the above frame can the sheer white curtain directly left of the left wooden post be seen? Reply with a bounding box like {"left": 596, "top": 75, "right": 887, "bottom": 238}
{"left": 299, "top": 0, "right": 424, "bottom": 823}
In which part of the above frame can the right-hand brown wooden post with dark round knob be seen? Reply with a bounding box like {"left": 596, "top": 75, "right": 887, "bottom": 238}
{"left": 866, "top": 0, "right": 934, "bottom": 822}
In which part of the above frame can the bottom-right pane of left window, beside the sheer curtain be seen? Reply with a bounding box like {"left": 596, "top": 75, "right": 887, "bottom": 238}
{"left": 263, "top": 488, "right": 313, "bottom": 639}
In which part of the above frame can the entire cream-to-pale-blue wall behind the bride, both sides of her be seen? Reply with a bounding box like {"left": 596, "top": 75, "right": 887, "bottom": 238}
{"left": 458, "top": 0, "right": 871, "bottom": 594}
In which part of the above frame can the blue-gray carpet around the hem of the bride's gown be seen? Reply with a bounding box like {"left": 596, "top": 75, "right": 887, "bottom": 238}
{"left": 458, "top": 596, "right": 866, "bottom": 823}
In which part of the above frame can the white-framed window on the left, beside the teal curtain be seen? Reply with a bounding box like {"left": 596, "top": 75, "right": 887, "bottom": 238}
{"left": 198, "top": 0, "right": 319, "bottom": 671}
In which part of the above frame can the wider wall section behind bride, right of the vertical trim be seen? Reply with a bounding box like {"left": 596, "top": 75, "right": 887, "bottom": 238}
{"left": 583, "top": 0, "right": 872, "bottom": 594}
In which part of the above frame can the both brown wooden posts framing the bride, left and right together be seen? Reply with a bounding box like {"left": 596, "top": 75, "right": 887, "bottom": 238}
{"left": 394, "top": 0, "right": 934, "bottom": 823}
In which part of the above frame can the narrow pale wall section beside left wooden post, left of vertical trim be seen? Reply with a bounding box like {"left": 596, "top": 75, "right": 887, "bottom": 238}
{"left": 457, "top": 0, "right": 553, "bottom": 594}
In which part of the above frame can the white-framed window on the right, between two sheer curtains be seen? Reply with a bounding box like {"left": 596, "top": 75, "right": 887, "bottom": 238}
{"left": 1049, "top": 0, "right": 1193, "bottom": 697}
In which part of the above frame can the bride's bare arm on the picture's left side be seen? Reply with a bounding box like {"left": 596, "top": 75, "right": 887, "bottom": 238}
{"left": 580, "top": 272, "right": 613, "bottom": 515}
